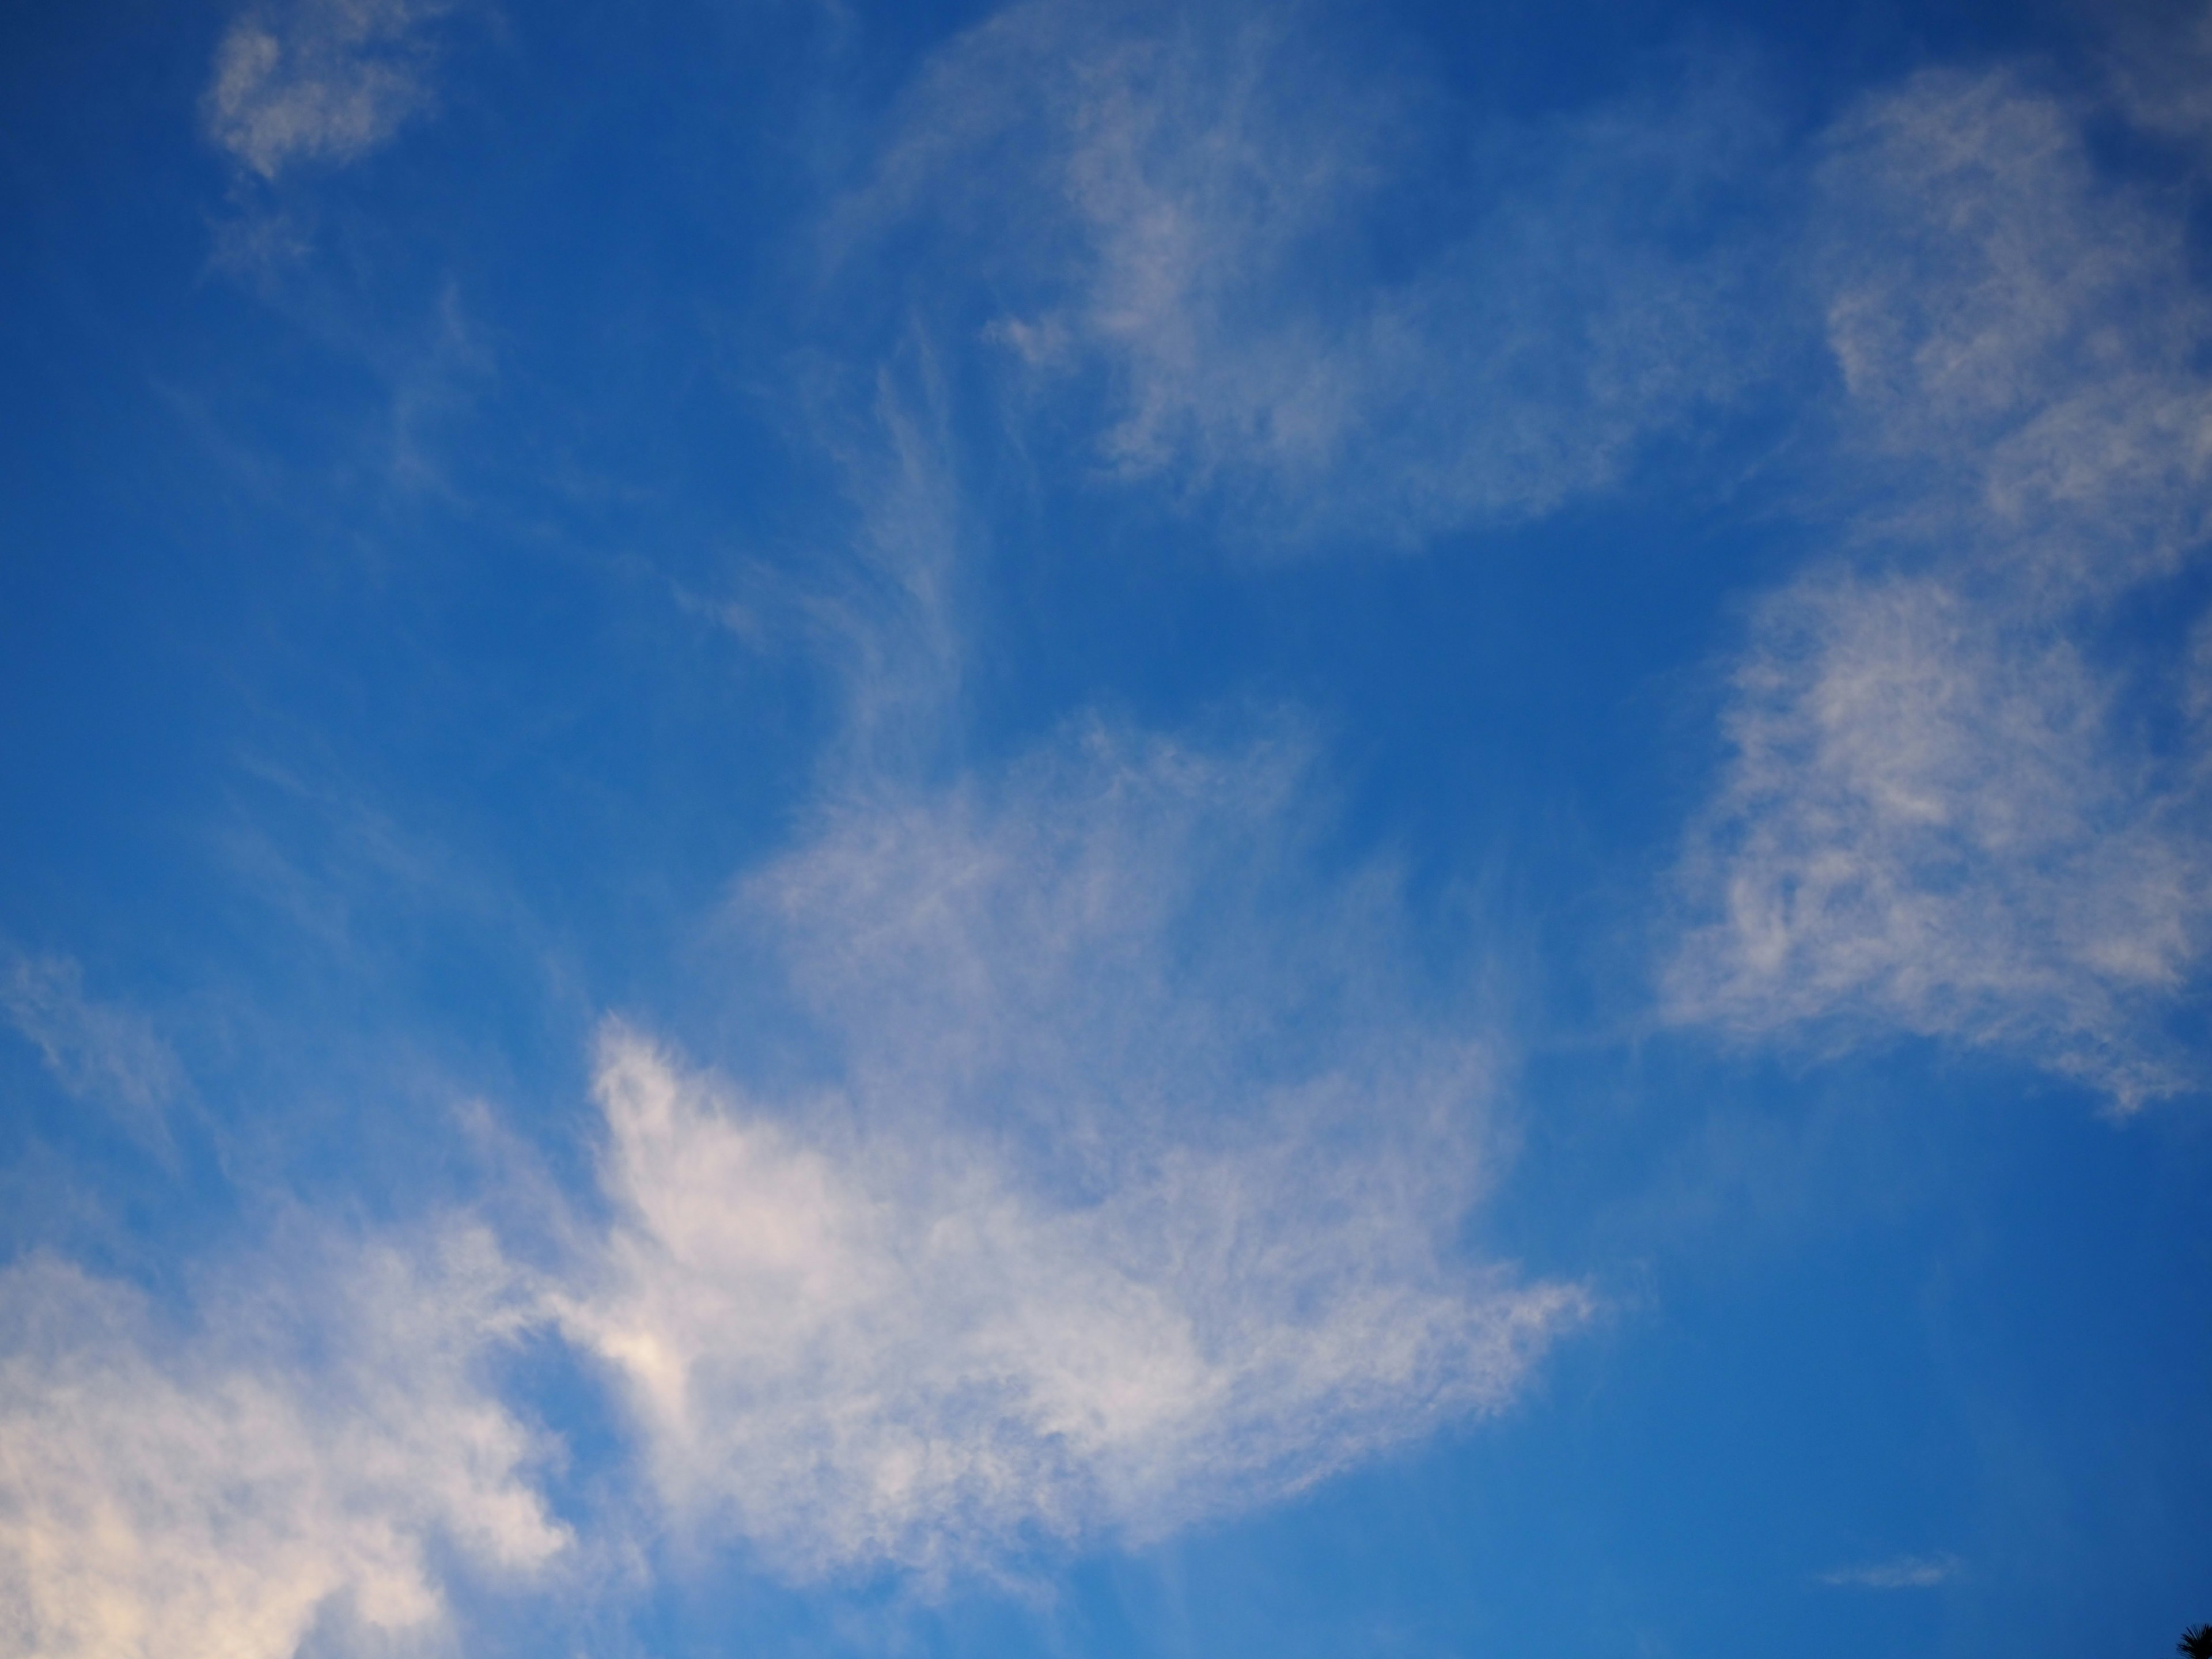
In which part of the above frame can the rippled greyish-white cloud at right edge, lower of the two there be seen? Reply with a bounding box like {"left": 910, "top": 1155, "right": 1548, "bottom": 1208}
{"left": 1668, "top": 577, "right": 2212, "bottom": 1106}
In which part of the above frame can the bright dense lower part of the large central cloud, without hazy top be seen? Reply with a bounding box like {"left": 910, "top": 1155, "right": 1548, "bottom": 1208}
{"left": 562, "top": 1029, "right": 1588, "bottom": 1577}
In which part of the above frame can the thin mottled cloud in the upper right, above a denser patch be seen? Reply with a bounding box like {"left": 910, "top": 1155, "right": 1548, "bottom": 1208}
{"left": 1818, "top": 73, "right": 2212, "bottom": 606}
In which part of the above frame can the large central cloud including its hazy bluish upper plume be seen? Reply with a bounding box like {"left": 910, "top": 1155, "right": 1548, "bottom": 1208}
{"left": 562, "top": 734, "right": 1588, "bottom": 1575}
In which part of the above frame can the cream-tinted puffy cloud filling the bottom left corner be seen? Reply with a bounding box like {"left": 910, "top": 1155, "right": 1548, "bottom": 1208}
{"left": 0, "top": 1232, "right": 564, "bottom": 1659}
